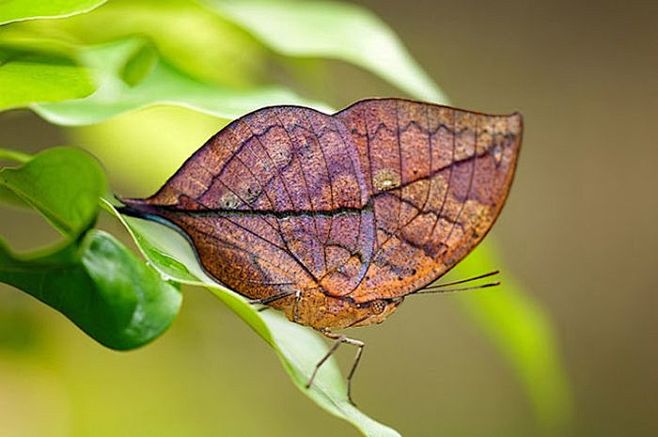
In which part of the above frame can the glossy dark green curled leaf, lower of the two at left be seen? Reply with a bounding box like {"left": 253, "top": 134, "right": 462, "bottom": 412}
{"left": 0, "top": 230, "right": 181, "bottom": 350}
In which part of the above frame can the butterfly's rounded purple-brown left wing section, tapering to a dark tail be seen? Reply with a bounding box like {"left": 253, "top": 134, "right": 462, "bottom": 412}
{"left": 124, "top": 107, "right": 374, "bottom": 298}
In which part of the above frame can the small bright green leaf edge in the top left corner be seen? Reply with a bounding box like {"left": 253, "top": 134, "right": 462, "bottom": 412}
{"left": 0, "top": 0, "right": 107, "bottom": 25}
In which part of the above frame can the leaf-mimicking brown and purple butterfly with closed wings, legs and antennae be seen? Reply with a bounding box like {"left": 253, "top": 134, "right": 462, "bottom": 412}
{"left": 120, "top": 98, "right": 523, "bottom": 400}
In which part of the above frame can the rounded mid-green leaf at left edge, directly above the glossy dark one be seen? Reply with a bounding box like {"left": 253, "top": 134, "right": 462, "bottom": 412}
{"left": 0, "top": 147, "right": 107, "bottom": 238}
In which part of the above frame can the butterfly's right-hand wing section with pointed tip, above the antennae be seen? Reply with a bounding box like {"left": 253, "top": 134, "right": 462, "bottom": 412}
{"left": 335, "top": 99, "right": 522, "bottom": 302}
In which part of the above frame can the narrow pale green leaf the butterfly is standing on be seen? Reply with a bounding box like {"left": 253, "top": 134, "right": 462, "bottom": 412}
{"left": 107, "top": 203, "right": 399, "bottom": 437}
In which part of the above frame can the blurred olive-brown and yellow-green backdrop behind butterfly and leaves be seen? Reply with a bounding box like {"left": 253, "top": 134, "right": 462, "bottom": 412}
{"left": 0, "top": 0, "right": 658, "bottom": 437}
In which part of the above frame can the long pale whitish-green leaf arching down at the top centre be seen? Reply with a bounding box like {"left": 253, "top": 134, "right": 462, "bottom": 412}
{"left": 204, "top": 0, "right": 447, "bottom": 103}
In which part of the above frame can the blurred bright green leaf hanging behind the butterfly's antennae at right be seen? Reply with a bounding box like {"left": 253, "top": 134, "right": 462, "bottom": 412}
{"left": 454, "top": 243, "right": 572, "bottom": 435}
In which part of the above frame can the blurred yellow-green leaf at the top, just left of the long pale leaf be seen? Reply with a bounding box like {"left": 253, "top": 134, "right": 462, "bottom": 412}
{"left": 20, "top": 0, "right": 271, "bottom": 88}
